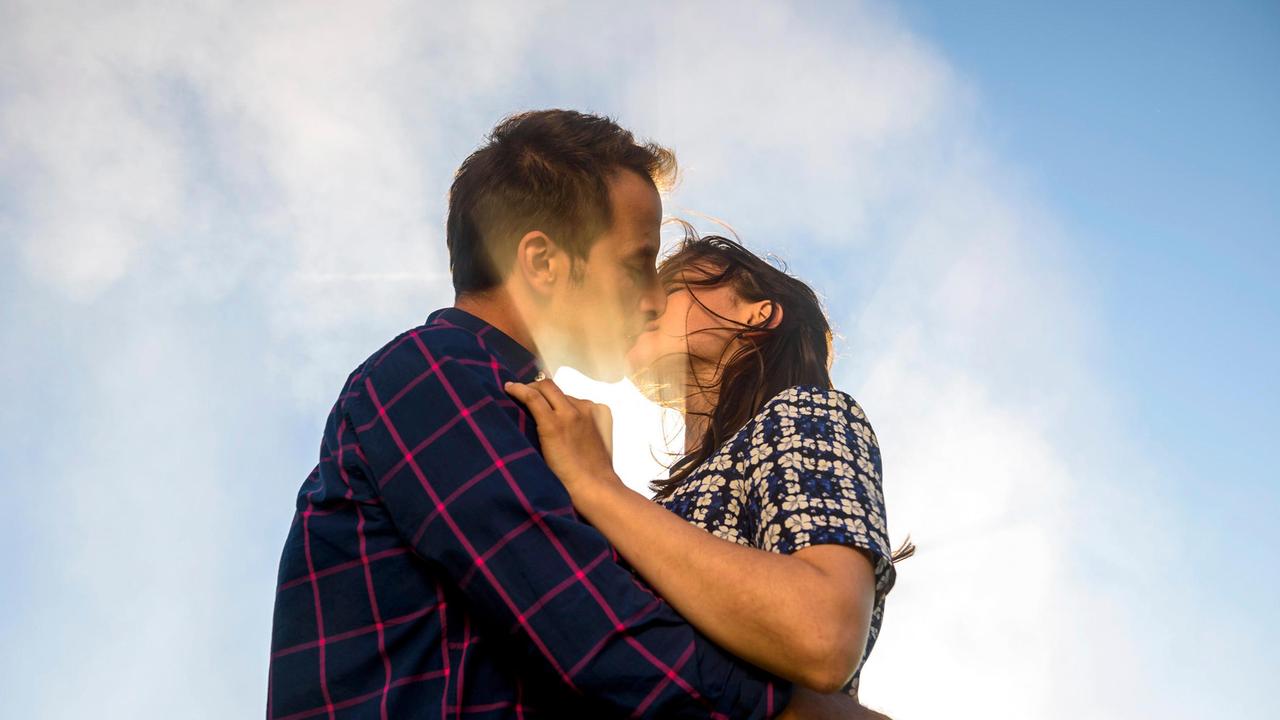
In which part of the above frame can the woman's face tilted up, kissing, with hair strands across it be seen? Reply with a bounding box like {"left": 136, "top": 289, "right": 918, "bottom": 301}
{"left": 627, "top": 266, "right": 759, "bottom": 401}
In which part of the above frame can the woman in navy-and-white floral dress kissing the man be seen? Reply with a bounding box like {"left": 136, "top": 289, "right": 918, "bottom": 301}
{"left": 507, "top": 234, "right": 911, "bottom": 717}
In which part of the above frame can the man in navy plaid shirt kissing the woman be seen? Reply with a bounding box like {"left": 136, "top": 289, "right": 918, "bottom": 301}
{"left": 268, "top": 110, "right": 791, "bottom": 719}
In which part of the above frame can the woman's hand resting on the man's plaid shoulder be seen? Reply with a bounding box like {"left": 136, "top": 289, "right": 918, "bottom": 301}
{"left": 504, "top": 379, "right": 622, "bottom": 505}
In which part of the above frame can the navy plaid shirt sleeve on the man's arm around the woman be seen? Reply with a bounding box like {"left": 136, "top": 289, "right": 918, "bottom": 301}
{"left": 348, "top": 334, "right": 790, "bottom": 717}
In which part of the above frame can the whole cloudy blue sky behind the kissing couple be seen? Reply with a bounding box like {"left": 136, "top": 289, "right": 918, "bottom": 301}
{"left": 0, "top": 0, "right": 1280, "bottom": 719}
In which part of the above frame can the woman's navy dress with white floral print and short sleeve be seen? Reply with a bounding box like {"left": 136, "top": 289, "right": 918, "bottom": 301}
{"left": 659, "top": 386, "right": 896, "bottom": 697}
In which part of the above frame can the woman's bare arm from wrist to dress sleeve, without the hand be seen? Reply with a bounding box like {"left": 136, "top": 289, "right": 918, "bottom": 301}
{"left": 573, "top": 475, "right": 876, "bottom": 693}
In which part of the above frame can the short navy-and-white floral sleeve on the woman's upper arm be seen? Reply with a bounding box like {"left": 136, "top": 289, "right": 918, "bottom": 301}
{"left": 740, "top": 386, "right": 896, "bottom": 598}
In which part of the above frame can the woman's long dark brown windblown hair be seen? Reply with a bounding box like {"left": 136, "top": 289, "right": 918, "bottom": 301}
{"left": 650, "top": 223, "right": 915, "bottom": 562}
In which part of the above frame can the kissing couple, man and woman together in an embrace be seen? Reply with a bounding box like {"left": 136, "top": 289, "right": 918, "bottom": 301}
{"left": 266, "top": 110, "right": 910, "bottom": 720}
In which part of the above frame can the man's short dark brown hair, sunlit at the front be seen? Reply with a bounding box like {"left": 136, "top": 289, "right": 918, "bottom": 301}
{"left": 445, "top": 110, "right": 676, "bottom": 295}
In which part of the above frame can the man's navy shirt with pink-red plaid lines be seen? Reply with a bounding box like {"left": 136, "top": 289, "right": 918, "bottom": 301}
{"left": 268, "top": 307, "right": 791, "bottom": 720}
